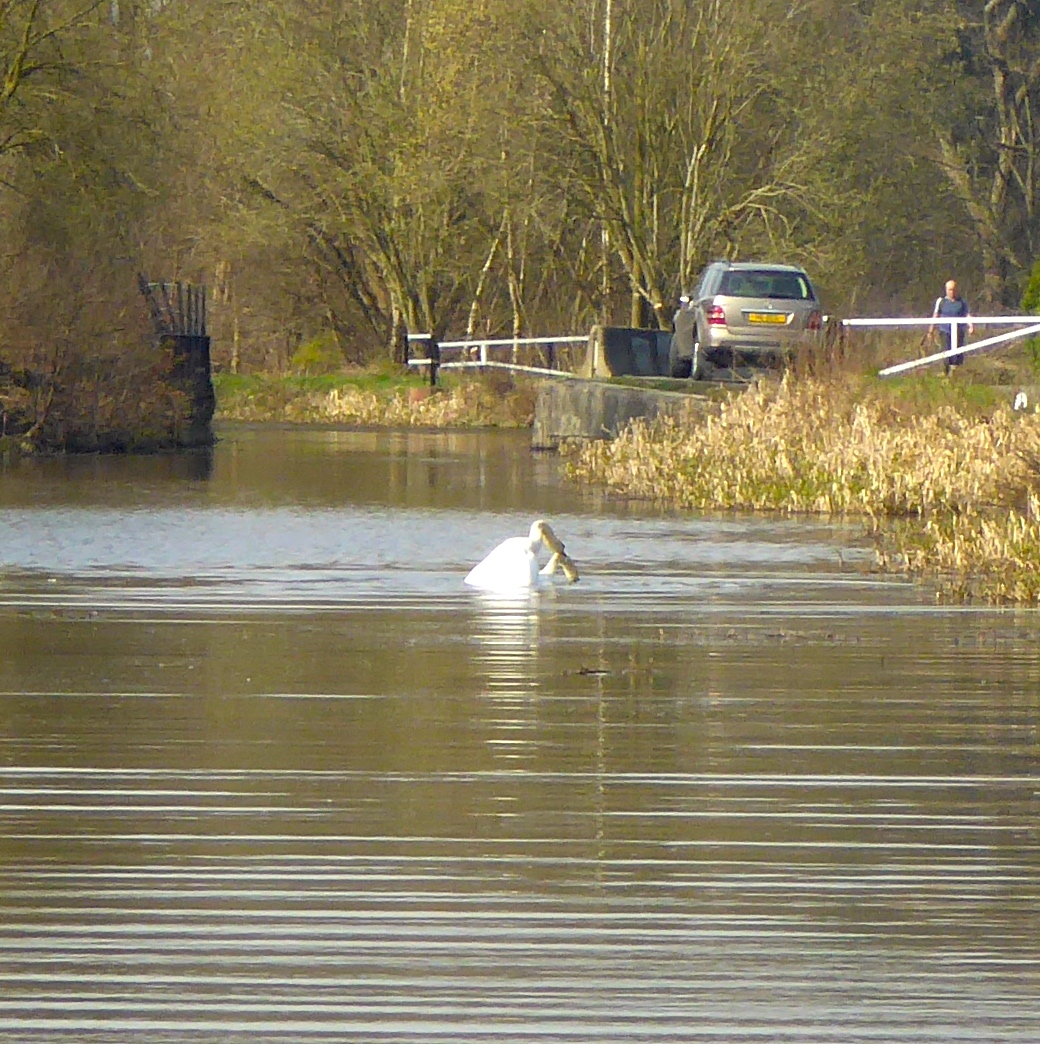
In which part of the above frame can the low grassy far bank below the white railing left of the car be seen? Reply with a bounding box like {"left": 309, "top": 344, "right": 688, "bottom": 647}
{"left": 213, "top": 370, "right": 536, "bottom": 428}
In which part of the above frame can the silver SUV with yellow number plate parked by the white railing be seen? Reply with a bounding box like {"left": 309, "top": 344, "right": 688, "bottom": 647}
{"left": 668, "top": 261, "right": 823, "bottom": 380}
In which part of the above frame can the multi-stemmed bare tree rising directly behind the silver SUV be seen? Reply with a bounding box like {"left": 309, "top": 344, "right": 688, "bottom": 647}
{"left": 536, "top": 0, "right": 826, "bottom": 327}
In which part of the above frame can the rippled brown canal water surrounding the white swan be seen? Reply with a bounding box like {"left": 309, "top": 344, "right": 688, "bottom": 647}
{"left": 0, "top": 427, "right": 1040, "bottom": 1044}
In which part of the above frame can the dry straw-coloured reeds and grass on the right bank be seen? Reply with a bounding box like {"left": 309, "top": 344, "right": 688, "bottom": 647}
{"left": 567, "top": 375, "right": 1040, "bottom": 604}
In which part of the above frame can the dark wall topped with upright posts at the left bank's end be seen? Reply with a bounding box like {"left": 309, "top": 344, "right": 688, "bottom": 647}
{"left": 138, "top": 276, "right": 216, "bottom": 446}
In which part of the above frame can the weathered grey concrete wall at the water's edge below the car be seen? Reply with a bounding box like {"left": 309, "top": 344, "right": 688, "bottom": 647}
{"left": 531, "top": 379, "right": 709, "bottom": 449}
